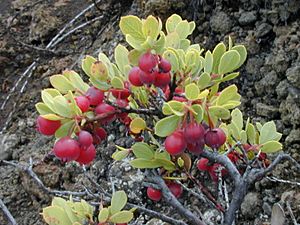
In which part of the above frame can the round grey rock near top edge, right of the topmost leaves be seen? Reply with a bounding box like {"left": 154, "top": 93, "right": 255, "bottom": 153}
{"left": 210, "top": 12, "right": 232, "bottom": 34}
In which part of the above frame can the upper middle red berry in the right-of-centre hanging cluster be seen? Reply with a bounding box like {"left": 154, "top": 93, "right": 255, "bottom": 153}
{"left": 183, "top": 123, "right": 205, "bottom": 143}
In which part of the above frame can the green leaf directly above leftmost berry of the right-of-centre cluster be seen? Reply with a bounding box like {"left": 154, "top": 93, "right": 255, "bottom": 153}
{"left": 155, "top": 115, "right": 181, "bottom": 137}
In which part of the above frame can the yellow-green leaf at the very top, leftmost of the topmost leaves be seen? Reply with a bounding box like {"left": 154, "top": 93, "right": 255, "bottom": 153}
{"left": 119, "top": 15, "right": 146, "bottom": 41}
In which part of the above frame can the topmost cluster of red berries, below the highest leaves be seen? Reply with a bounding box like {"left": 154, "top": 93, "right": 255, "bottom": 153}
{"left": 128, "top": 52, "right": 171, "bottom": 88}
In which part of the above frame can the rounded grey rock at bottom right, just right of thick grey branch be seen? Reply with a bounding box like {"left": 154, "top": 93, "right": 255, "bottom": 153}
{"left": 241, "top": 192, "right": 261, "bottom": 218}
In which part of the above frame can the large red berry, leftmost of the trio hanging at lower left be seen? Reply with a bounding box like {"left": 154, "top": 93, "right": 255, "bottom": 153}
{"left": 53, "top": 137, "right": 80, "bottom": 161}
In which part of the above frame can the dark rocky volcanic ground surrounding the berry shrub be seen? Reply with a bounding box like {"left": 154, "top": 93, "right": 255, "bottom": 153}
{"left": 0, "top": 0, "right": 300, "bottom": 225}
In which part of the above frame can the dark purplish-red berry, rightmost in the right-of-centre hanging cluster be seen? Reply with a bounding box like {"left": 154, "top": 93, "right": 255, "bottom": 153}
{"left": 204, "top": 128, "right": 226, "bottom": 148}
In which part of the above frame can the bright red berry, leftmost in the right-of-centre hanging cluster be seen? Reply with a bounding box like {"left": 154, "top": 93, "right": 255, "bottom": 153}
{"left": 165, "top": 131, "right": 186, "bottom": 155}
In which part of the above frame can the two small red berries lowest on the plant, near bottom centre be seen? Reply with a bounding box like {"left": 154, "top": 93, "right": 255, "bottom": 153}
{"left": 147, "top": 182, "right": 183, "bottom": 202}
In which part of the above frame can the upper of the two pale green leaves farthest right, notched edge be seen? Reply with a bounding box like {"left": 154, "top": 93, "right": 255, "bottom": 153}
{"left": 259, "top": 121, "right": 282, "bottom": 144}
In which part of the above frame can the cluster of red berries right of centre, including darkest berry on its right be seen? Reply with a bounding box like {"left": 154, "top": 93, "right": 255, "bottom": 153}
{"left": 165, "top": 122, "right": 226, "bottom": 155}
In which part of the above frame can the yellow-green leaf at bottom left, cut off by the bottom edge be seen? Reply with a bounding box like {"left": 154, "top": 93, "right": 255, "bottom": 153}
{"left": 42, "top": 206, "right": 72, "bottom": 225}
